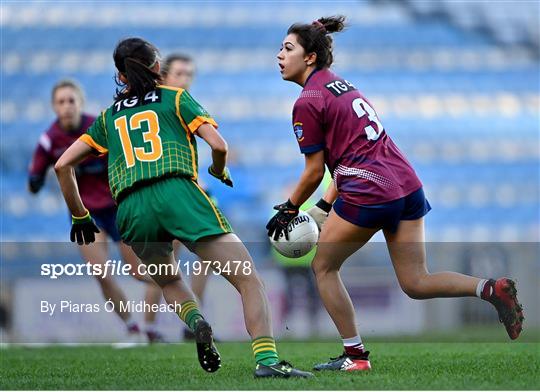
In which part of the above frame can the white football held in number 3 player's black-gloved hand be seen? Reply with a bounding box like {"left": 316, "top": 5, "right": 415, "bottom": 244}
{"left": 270, "top": 211, "right": 319, "bottom": 259}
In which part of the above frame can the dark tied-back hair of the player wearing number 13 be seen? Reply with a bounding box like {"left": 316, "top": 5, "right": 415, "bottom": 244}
{"left": 113, "top": 38, "right": 161, "bottom": 100}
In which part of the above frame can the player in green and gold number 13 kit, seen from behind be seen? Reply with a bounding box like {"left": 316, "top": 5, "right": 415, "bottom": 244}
{"left": 55, "top": 38, "right": 312, "bottom": 378}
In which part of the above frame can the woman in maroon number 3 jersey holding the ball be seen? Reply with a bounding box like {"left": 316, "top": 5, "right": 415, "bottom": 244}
{"left": 267, "top": 16, "right": 523, "bottom": 371}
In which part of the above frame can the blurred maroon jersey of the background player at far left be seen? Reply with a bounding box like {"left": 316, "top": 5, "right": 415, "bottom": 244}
{"left": 29, "top": 115, "right": 115, "bottom": 212}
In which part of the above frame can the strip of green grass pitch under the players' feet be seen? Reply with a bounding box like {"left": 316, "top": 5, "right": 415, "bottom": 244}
{"left": 0, "top": 342, "right": 540, "bottom": 390}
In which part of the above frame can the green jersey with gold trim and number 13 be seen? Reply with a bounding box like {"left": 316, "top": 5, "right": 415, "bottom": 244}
{"left": 80, "top": 86, "right": 217, "bottom": 199}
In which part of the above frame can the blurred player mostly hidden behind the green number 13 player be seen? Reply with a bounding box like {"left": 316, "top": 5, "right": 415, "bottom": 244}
{"left": 161, "top": 53, "right": 211, "bottom": 339}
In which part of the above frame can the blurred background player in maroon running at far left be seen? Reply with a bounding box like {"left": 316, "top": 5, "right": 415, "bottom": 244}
{"left": 29, "top": 80, "right": 161, "bottom": 342}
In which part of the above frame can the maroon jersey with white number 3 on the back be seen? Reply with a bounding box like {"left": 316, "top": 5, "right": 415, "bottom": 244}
{"left": 293, "top": 69, "right": 422, "bottom": 205}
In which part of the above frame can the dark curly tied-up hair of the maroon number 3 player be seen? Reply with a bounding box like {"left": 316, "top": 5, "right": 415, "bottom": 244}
{"left": 287, "top": 15, "right": 345, "bottom": 68}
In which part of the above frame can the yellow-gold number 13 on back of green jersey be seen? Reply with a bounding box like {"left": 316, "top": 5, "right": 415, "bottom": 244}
{"left": 114, "top": 110, "right": 163, "bottom": 168}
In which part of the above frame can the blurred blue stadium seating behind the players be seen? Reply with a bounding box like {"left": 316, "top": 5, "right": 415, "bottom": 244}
{"left": 0, "top": 2, "right": 540, "bottom": 245}
